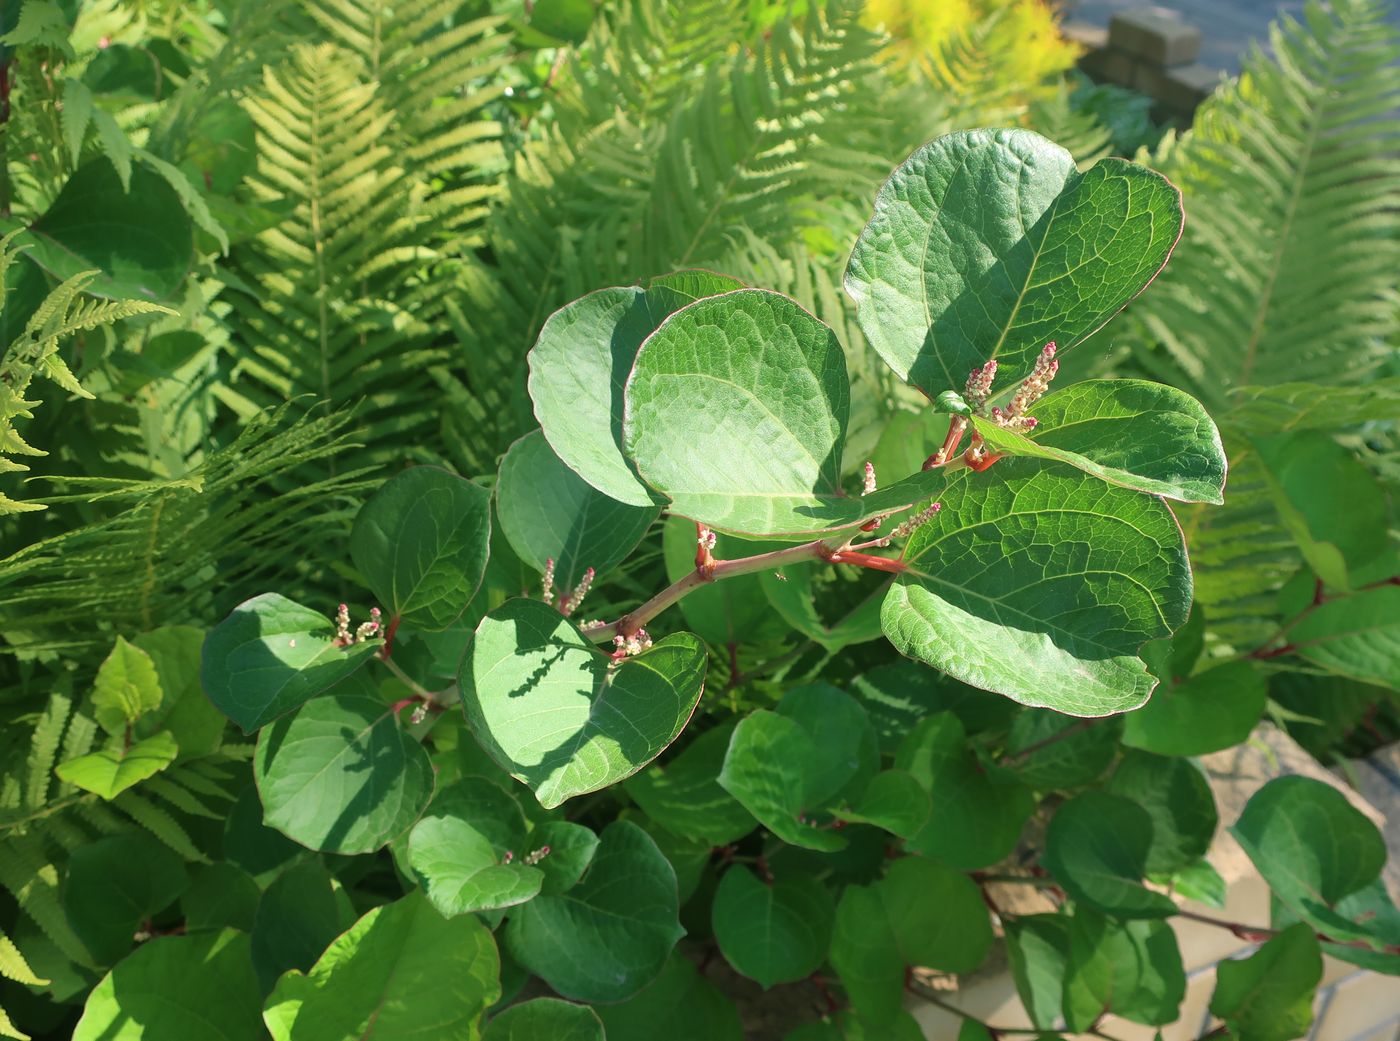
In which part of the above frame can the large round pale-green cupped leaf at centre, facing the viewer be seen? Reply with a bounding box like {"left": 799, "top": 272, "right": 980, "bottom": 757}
{"left": 623, "top": 290, "right": 942, "bottom": 537}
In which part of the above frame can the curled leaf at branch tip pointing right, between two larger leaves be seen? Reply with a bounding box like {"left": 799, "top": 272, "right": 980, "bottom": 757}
{"left": 973, "top": 379, "right": 1225, "bottom": 504}
